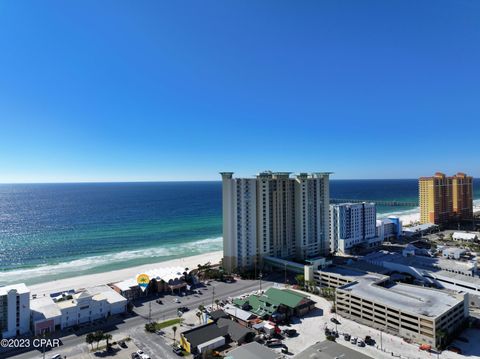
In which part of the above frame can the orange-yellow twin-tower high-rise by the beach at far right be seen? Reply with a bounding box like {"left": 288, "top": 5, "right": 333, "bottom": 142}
{"left": 419, "top": 172, "right": 473, "bottom": 224}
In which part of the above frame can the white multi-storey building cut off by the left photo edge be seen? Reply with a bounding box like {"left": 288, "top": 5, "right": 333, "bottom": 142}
{"left": 0, "top": 283, "right": 30, "bottom": 338}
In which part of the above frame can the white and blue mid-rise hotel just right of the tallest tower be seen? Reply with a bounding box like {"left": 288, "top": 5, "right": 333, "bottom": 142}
{"left": 330, "top": 203, "right": 383, "bottom": 253}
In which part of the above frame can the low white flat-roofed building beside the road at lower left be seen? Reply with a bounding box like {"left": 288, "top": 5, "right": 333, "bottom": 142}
{"left": 31, "top": 285, "right": 127, "bottom": 335}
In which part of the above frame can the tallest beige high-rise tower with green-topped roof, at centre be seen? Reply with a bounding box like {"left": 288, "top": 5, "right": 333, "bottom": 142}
{"left": 221, "top": 171, "right": 330, "bottom": 271}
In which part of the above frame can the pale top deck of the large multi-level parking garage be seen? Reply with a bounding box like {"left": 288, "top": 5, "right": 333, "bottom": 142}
{"left": 338, "top": 275, "right": 463, "bottom": 318}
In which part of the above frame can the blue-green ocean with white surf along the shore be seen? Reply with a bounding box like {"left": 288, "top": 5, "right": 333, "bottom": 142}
{"left": 0, "top": 179, "right": 480, "bottom": 286}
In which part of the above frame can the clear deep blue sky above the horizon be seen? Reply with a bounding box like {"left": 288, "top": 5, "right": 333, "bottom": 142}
{"left": 0, "top": 0, "right": 480, "bottom": 182}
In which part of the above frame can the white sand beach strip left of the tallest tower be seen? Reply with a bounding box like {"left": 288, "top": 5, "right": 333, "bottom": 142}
{"left": 29, "top": 251, "right": 223, "bottom": 296}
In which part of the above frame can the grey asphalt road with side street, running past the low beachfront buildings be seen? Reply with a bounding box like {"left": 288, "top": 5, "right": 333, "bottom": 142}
{"left": 5, "top": 276, "right": 283, "bottom": 359}
